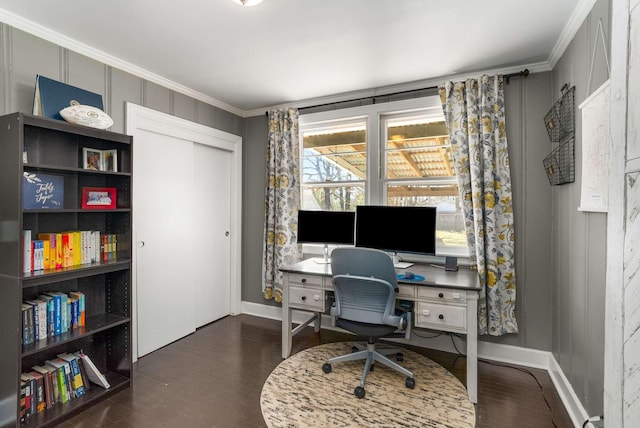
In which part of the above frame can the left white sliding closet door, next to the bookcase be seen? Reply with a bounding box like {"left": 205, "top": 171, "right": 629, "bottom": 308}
{"left": 133, "top": 130, "right": 199, "bottom": 357}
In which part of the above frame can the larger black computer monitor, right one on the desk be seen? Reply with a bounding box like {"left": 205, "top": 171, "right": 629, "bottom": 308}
{"left": 356, "top": 205, "right": 436, "bottom": 268}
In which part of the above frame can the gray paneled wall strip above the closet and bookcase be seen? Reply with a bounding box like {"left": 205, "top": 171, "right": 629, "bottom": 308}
{"left": 0, "top": 24, "right": 243, "bottom": 135}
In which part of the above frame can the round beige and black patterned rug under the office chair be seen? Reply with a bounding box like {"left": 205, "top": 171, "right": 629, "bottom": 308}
{"left": 260, "top": 342, "right": 475, "bottom": 428}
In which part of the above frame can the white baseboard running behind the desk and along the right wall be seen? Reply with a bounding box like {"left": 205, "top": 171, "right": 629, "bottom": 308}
{"left": 242, "top": 302, "right": 588, "bottom": 427}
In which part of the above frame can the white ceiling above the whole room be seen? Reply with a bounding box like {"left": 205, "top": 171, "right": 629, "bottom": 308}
{"left": 0, "top": 0, "right": 595, "bottom": 116}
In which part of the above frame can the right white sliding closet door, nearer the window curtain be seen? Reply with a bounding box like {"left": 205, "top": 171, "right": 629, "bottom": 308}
{"left": 193, "top": 144, "right": 231, "bottom": 327}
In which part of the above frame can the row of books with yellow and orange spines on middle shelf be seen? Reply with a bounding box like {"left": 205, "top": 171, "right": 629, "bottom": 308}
{"left": 22, "top": 230, "right": 118, "bottom": 273}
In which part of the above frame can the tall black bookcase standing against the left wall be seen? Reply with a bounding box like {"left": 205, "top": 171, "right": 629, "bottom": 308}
{"left": 0, "top": 113, "right": 132, "bottom": 427}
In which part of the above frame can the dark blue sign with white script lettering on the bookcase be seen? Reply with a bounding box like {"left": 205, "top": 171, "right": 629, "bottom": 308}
{"left": 22, "top": 172, "right": 64, "bottom": 209}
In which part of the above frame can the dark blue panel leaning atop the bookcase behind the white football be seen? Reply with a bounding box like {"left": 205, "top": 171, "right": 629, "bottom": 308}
{"left": 33, "top": 75, "right": 104, "bottom": 120}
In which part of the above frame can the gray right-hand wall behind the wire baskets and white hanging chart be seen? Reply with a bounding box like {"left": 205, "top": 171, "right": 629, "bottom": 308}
{"left": 550, "top": 0, "right": 611, "bottom": 415}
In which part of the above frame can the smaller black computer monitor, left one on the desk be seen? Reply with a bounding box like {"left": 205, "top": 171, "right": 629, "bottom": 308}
{"left": 298, "top": 210, "right": 356, "bottom": 263}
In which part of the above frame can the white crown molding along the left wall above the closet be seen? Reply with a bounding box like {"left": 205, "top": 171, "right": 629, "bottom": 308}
{"left": 0, "top": 9, "right": 245, "bottom": 117}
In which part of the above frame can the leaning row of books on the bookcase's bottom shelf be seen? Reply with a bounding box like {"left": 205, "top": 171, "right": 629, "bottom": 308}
{"left": 20, "top": 351, "right": 110, "bottom": 422}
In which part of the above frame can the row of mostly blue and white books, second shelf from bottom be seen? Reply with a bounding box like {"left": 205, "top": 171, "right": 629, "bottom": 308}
{"left": 22, "top": 291, "right": 86, "bottom": 345}
